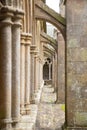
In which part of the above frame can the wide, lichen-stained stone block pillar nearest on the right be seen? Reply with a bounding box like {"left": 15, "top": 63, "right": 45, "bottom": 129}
{"left": 65, "top": 0, "right": 87, "bottom": 130}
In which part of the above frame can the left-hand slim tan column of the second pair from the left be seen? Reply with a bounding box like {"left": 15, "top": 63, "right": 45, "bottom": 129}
{"left": 20, "top": 35, "right": 25, "bottom": 114}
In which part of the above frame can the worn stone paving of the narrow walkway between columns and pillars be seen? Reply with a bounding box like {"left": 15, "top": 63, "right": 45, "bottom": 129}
{"left": 35, "top": 85, "right": 65, "bottom": 130}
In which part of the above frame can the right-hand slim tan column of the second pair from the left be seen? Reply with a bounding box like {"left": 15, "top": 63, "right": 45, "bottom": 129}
{"left": 25, "top": 35, "right": 31, "bottom": 114}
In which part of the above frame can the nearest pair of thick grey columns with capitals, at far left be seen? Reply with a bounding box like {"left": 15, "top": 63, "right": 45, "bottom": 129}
{"left": 0, "top": 4, "right": 23, "bottom": 129}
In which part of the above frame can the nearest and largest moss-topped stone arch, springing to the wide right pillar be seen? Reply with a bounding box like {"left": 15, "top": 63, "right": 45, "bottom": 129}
{"left": 35, "top": 0, "right": 66, "bottom": 39}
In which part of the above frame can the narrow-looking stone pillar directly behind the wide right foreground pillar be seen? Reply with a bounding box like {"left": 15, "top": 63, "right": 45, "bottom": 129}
{"left": 57, "top": 32, "right": 65, "bottom": 103}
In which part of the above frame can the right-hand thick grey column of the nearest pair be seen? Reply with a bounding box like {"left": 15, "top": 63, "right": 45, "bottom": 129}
{"left": 12, "top": 16, "right": 21, "bottom": 123}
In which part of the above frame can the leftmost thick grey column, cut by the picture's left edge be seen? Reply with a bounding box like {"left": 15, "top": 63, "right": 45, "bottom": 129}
{"left": 0, "top": 12, "right": 12, "bottom": 130}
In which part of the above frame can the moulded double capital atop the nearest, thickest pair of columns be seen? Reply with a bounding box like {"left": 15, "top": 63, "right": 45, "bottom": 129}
{"left": 0, "top": 6, "right": 24, "bottom": 26}
